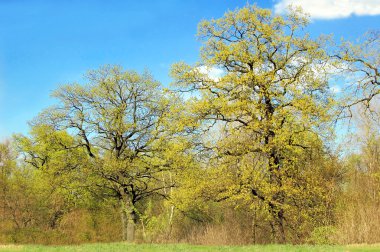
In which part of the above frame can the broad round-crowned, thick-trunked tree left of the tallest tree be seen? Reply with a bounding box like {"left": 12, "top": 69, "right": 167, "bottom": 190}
{"left": 34, "top": 66, "right": 187, "bottom": 241}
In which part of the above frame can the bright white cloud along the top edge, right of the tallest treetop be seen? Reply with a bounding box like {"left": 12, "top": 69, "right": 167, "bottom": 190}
{"left": 274, "top": 0, "right": 380, "bottom": 19}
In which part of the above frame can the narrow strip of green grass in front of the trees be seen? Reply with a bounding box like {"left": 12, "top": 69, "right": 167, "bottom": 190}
{"left": 0, "top": 243, "right": 380, "bottom": 252}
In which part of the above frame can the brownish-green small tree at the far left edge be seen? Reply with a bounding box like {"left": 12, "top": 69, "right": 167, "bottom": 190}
{"left": 0, "top": 141, "right": 48, "bottom": 242}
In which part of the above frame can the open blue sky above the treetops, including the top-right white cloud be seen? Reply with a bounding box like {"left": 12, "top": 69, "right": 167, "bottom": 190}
{"left": 0, "top": 0, "right": 380, "bottom": 140}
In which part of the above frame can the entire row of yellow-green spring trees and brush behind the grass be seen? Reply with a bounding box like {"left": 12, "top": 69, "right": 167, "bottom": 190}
{"left": 0, "top": 6, "right": 380, "bottom": 244}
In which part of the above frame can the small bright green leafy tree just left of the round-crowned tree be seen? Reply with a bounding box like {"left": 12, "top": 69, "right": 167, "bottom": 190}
{"left": 14, "top": 124, "right": 95, "bottom": 229}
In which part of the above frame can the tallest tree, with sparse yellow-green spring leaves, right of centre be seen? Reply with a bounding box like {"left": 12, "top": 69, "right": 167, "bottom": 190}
{"left": 172, "top": 6, "right": 340, "bottom": 243}
